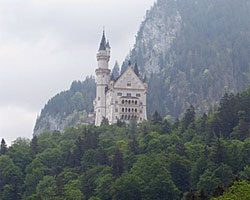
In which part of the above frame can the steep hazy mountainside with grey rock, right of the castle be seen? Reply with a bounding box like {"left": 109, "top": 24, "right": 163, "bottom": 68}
{"left": 128, "top": 0, "right": 250, "bottom": 117}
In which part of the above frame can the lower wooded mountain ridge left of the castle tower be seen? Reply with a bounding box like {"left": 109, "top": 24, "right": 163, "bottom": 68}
{"left": 34, "top": 76, "right": 96, "bottom": 135}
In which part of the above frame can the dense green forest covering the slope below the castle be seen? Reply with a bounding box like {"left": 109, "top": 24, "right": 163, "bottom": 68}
{"left": 0, "top": 88, "right": 250, "bottom": 200}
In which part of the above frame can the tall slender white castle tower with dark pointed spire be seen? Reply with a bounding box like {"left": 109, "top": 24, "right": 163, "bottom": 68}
{"left": 95, "top": 31, "right": 110, "bottom": 126}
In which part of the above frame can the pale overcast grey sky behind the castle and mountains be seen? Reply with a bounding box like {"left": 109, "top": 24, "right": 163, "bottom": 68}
{"left": 0, "top": 0, "right": 155, "bottom": 144}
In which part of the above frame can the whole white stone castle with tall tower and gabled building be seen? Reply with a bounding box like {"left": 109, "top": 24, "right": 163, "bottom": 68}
{"left": 94, "top": 31, "right": 147, "bottom": 126}
